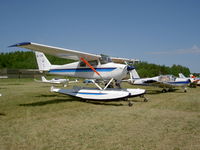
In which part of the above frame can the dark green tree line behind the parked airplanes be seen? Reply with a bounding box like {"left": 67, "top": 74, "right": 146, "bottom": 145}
{"left": 0, "top": 51, "right": 190, "bottom": 77}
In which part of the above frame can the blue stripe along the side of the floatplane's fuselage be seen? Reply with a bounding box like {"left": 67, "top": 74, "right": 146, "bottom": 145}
{"left": 49, "top": 68, "right": 116, "bottom": 73}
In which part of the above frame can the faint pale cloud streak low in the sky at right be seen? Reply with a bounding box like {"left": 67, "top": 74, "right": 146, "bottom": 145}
{"left": 147, "top": 45, "right": 200, "bottom": 55}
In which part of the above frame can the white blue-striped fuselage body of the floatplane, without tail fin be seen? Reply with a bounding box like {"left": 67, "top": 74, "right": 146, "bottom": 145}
{"left": 49, "top": 61, "right": 127, "bottom": 80}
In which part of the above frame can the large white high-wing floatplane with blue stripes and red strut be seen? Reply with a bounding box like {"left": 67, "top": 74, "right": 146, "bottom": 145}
{"left": 10, "top": 42, "right": 147, "bottom": 106}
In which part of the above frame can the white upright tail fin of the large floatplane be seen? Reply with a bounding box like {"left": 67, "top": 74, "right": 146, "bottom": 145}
{"left": 35, "top": 51, "right": 51, "bottom": 71}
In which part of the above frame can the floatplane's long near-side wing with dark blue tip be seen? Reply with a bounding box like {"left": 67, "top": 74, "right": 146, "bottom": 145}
{"left": 9, "top": 42, "right": 101, "bottom": 61}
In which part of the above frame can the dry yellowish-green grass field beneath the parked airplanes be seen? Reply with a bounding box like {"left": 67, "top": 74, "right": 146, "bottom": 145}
{"left": 0, "top": 79, "right": 200, "bottom": 150}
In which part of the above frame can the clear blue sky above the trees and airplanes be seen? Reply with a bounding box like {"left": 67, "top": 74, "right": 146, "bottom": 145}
{"left": 0, "top": 0, "right": 200, "bottom": 73}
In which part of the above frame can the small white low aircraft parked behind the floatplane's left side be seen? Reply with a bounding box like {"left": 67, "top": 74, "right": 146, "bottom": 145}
{"left": 35, "top": 76, "right": 78, "bottom": 87}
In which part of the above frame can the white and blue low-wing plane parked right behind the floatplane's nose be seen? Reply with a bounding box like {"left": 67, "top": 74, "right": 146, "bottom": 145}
{"left": 126, "top": 69, "right": 190, "bottom": 93}
